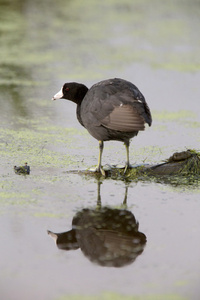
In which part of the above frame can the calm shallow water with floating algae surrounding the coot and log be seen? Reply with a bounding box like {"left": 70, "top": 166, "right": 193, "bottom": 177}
{"left": 0, "top": 0, "right": 200, "bottom": 300}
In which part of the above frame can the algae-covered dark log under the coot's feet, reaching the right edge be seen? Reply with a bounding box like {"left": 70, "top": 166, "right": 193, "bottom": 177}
{"left": 75, "top": 150, "right": 200, "bottom": 192}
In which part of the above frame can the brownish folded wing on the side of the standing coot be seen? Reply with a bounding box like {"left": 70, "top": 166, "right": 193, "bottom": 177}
{"left": 101, "top": 104, "right": 145, "bottom": 132}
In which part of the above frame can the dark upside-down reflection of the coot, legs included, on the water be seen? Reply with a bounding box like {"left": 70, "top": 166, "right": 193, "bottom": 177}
{"left": 48, "top": 182, "right": 146, "bottom": 267}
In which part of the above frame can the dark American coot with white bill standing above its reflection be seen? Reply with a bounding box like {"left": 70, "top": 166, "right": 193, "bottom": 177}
{"left": 52, "top": 78, "right": 152, "bottom": 175}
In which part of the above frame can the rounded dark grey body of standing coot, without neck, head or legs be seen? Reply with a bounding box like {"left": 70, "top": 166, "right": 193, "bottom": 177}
{"left": 80, "top": 78, "right": 152, "bottom": 140}
